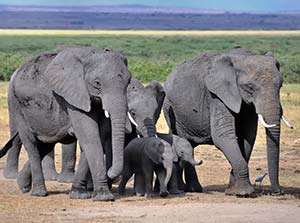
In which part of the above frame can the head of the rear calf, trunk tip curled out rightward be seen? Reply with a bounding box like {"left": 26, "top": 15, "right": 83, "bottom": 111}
{"left": 172, "top": 135, "right": 202, "bottom": 166}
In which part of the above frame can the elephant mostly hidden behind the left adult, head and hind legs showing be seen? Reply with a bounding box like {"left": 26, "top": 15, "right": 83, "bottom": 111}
{"left": 4, "top": 78, "right": 165, "bottom": 183}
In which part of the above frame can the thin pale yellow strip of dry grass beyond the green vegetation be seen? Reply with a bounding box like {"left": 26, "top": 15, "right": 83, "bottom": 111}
{"left": 0, "top": 29, "right": 300, "bottom": 36}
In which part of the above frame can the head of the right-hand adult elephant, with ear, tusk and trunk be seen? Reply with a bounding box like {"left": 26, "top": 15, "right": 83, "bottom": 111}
{"left": 204, "top": 49, "right": 283, "bottom": 192}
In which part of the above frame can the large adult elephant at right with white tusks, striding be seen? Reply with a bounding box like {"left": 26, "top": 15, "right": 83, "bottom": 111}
{"left": 163, "top": 48, "right": 282, "bottom": 196}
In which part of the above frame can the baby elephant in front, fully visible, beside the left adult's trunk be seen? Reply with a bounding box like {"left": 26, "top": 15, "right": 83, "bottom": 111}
{"left": 119, "top": 137, "right": 178, "bottom": 197}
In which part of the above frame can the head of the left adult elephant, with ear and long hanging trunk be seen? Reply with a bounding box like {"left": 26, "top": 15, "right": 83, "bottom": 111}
{"left": 45, "top": 47, "right": 131, "bottom": 179}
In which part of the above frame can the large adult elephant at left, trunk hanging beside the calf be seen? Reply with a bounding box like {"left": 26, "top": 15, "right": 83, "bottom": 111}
{"left": 0, "top": 47, "right": 131, "bottom": 201}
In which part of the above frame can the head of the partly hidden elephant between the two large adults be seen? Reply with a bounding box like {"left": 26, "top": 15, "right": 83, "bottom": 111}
{"left": 127, "top": 78, "right": 165, "bottom": 137}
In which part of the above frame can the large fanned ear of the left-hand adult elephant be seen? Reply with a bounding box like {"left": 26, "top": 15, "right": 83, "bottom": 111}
{"left": 44, "top": 48, "right": 91, "bottom": 112}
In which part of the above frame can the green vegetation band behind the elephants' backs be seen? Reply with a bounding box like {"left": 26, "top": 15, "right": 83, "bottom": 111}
{"left": 0, "top": 35, "right": 300, "bottom": 83}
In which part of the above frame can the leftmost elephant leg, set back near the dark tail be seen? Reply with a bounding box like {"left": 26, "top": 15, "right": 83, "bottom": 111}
{"left": 3, "top": 136, "right": 22, "bottom": 179}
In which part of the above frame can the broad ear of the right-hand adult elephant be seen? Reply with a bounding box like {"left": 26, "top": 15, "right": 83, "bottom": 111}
{"left": 204, "top": 56, "right": 242, "bottom": 113}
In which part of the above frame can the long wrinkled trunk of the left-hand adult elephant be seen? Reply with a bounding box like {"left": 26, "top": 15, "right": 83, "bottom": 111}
{"left": 103, "top": 94, "right": 127, "bottom": 179}
